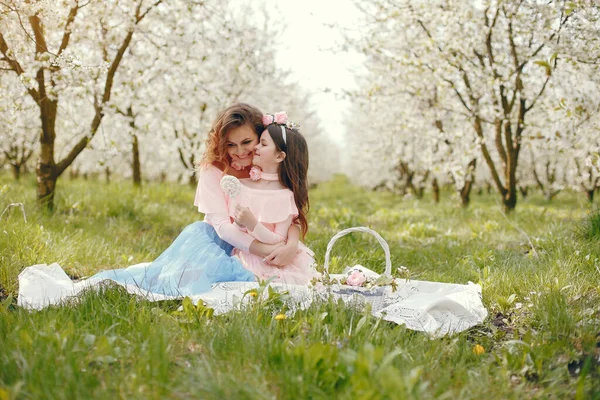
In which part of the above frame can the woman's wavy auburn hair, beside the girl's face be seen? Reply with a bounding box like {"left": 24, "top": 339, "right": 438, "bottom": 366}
{"left": 200, "top": 103, "right": 264, "bottom": 172}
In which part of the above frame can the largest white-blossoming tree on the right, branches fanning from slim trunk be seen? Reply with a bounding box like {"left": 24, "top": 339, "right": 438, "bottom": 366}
{"left": 346, "top": 0, "right": 592, "bottom": 210}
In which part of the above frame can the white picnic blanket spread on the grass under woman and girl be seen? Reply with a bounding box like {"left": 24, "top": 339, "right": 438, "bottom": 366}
{"left": 18, "top": 263, "right": 487, "bottom": 337}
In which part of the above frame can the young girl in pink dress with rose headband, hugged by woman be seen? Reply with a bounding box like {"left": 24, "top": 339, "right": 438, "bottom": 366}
{"left": 207, "top": 113, "right": 318, "bottom": 284}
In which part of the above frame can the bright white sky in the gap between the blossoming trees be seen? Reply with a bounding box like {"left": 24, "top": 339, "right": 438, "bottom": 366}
{"left": 277, "top": 0, "right": 362, "bottom": 144}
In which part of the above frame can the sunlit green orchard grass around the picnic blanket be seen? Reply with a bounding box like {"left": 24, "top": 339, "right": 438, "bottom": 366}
{"left": 0, "top": 175, "right": 600, "bottom": 400}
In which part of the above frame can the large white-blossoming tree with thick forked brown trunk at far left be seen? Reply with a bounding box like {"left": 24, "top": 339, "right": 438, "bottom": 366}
{"left": 0, "top": 0, "right": 162, "bottom": 208}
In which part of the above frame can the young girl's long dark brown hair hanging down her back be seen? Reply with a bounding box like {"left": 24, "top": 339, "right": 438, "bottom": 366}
{"left": 267, "top": 124, "right": 310, "bottom": 238}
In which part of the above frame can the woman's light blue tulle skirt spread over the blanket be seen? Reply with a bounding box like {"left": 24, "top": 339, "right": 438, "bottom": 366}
{"left": 92, "top": 222, "right": 255, "bottom": 296}
